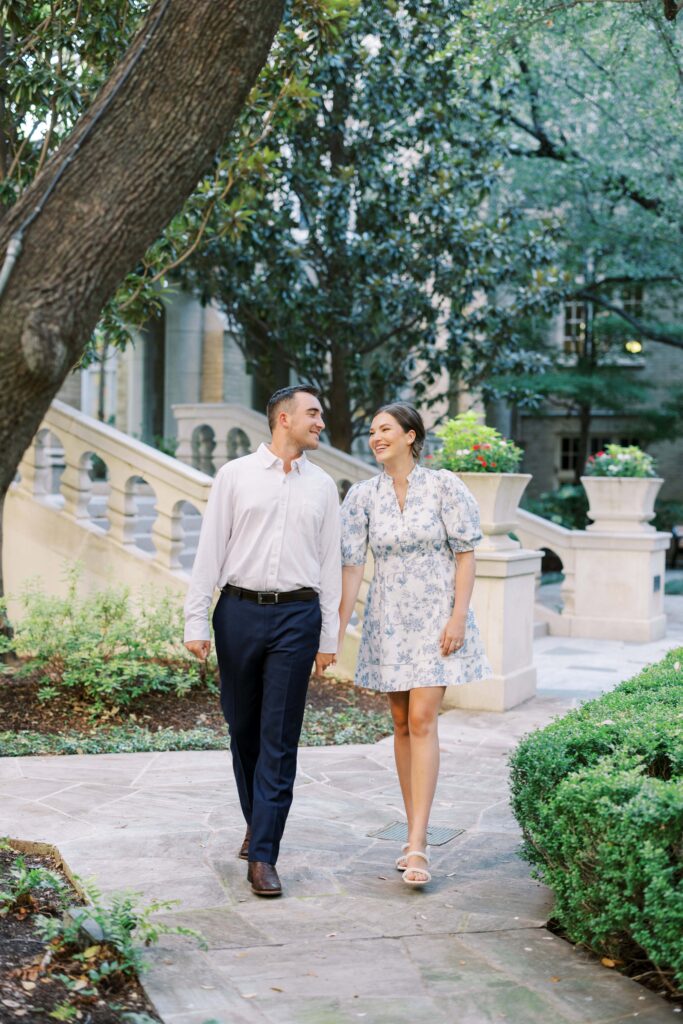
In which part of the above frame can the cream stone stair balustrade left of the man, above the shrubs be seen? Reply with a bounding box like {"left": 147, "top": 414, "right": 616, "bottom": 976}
{"left": 8, "top": 401, "right": 212, "bottom": 589}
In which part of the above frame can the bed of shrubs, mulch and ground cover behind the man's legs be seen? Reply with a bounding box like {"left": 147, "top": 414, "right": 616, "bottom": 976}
{"left": 0, "top": 575, "right": 392, "bottom": 757}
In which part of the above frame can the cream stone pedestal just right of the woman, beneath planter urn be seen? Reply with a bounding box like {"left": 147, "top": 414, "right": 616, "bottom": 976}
{"left": 443, "top": 547, "right": 541, "bottom": 711}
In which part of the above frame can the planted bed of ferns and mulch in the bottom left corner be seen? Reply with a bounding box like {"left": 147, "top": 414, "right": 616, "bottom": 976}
{"left": 0, "top": 841, "right": 201, "bottom": 1024}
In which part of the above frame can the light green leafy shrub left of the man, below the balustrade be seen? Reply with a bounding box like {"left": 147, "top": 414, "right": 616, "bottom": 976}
{"left": 2, "top": 570, "right": 214, "bottom": 714}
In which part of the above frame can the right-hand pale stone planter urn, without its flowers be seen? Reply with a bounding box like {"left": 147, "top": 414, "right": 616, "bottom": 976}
{"left": 581, "top": 476, "right": 664, "bottom": 534}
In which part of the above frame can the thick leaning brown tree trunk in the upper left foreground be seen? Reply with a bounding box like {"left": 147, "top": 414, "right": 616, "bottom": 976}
{"left": 0, "top": 0, "right": 283, "bottom": 598}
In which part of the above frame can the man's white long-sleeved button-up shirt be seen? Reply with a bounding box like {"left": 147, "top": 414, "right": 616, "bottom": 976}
{"left": 185, "top": 444, "right": 341, "bottom": 654}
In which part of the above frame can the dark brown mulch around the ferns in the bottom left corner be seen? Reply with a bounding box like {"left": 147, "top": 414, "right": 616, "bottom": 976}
{"left": 0, "top": 850, "right": 160, "bottom": 1024}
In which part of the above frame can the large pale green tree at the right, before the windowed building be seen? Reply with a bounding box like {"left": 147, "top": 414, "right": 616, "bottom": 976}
{"left": 450, "top": 0, "right": 683, "bottom": 460}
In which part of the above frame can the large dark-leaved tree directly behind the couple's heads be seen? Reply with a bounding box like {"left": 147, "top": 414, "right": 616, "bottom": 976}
{"left": 182, "top": 0, "right": 550, "bottom": 451}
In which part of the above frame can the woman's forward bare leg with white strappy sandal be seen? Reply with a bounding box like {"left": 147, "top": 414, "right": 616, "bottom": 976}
{"left": 408, "top": 686, "right": 445, "bottom": 878}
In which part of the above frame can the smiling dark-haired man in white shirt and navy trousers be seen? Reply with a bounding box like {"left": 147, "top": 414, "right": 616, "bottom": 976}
{"left": 185, "top": 386, "right": 341, "bottom": 896}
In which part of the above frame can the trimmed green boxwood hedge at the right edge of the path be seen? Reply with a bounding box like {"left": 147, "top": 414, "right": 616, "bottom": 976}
{"left": 511, "top": 648, "right": 683, "bottom": 988}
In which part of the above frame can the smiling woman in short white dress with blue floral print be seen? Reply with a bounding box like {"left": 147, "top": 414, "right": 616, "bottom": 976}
{"left": 340, "top": 402, "right": 492, "bottom": 886}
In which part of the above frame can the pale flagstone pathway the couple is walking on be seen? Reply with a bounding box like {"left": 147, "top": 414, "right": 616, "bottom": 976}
{"left": 0, "top": 598, "right": 683, "bottom": 1024}
